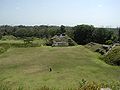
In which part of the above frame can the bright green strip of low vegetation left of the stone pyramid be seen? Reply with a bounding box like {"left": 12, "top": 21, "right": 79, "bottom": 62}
{"left": 0, "top": 38, "right": 47, "bottom": 49}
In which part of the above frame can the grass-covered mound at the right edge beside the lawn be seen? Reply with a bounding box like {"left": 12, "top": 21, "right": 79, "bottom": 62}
{"left": 103, "top": 46, "right": 120, "bottom": 66}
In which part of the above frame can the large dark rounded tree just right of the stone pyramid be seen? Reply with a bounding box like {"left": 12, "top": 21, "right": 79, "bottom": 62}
{"left": 73, "top": 25, "right": 95, "bottom": 44}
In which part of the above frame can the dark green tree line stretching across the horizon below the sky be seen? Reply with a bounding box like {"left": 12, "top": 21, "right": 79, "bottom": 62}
{"left": 0, "top": 24, "right": 120, "bottom": 44}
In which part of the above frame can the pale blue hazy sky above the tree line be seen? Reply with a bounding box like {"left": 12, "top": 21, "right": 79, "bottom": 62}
{"left": 0, "top": 0, "right": 120, "bottom": 27}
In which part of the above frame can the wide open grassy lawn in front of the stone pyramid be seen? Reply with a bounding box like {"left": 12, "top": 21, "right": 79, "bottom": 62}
{"left": 0, "top": 46, "right": 120, "bottom": 90}
